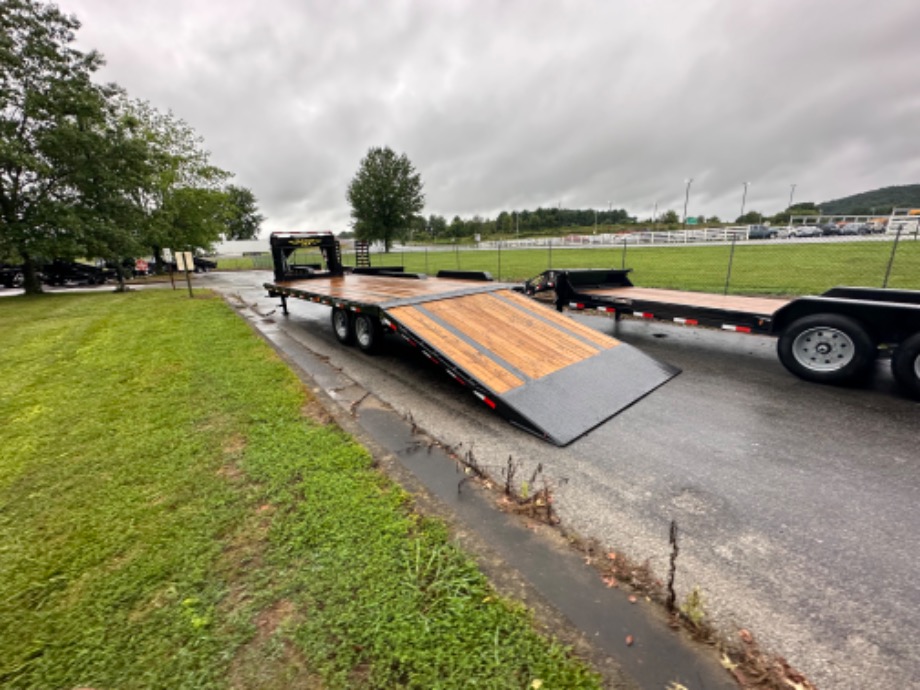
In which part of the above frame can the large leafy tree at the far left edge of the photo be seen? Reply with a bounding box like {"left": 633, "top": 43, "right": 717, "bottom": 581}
{"left": 0, "top": 0, "right": 122, "bottom": 292}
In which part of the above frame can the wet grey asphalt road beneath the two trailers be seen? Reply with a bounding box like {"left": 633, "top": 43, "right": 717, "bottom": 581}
{"left": 198, "top": 272, "right": 920, "bottom": 690}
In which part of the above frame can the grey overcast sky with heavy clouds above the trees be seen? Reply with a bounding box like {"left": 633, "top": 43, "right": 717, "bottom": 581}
{"left": 60, "top": 0, "right": 920, "bottom": 232}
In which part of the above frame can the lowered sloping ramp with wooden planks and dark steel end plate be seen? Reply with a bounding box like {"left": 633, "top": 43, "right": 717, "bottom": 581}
{"left": 381, "top": 289, "right": 679, "bottom": 446}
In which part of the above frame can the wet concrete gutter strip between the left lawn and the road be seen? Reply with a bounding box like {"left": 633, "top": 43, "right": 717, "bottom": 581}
{"left": 244, "top": 306, "right": 738, "bottom": 690}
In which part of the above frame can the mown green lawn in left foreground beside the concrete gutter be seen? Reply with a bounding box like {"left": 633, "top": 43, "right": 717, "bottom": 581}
{"left": 0, "top": 290, "right": 599, "bottom": 688}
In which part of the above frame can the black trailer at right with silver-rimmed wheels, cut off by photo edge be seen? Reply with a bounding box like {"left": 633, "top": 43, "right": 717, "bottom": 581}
{"left": 524, "top": 269, "right": 920, "bottom": 398}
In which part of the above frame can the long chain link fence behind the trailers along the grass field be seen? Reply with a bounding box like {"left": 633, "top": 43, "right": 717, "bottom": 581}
{"left": 358, "top": 229, "right": 920, "bottom": 296}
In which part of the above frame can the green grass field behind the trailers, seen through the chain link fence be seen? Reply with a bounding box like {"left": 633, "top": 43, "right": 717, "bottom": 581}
{"left": 219, "top": 239, "right": 920, "bottom": 295}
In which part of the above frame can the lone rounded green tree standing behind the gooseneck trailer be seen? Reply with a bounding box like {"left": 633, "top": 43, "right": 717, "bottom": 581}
{"left": 346, "top": 147, "right": 425, "bottom": 252}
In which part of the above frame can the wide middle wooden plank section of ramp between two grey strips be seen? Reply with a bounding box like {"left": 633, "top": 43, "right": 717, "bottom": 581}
{"left": 424, "top": 293, "right": 601, "bottom": 379}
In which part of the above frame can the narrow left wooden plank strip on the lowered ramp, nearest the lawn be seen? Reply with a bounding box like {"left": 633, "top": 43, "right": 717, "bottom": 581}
{"left": 387, "top": 307, "right": 524, "bottom": 395}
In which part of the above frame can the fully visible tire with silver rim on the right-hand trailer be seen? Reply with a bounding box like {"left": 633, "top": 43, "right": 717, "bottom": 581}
{"left": 777, "top": 314, "right": 877, "bottom": 383}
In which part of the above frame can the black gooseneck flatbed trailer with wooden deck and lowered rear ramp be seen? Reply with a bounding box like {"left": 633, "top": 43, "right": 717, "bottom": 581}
{"left": 265, "top": 233, "right": 678, "bottom": 445}
